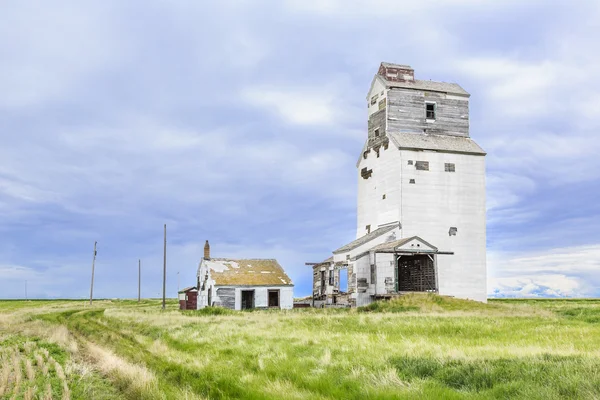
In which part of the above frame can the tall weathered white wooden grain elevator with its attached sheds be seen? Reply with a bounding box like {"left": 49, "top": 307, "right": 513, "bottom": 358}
{"left": 307, "top": 63, "right": 487, "bottom": 306}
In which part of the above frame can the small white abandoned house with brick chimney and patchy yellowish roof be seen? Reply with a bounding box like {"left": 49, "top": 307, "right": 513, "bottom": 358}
{"left": 198, "top": 240, "right": 294, "bottom": 310}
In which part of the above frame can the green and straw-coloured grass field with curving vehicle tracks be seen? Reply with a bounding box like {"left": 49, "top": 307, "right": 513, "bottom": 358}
{"left": 0, "top": 295, "right": 600, "bottom": 400}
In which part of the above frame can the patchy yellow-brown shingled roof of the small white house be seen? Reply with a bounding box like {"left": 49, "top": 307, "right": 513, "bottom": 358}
{"left": 201, "top": 258, "right": 293, "bottom": 286}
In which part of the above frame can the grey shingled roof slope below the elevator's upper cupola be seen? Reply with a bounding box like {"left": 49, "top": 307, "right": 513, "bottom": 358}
{"left": 387, "top": 132, "right": 486, "bottom": 155}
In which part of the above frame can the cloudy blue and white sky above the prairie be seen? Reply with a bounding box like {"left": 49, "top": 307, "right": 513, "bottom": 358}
{"left": 0, "top": 0, "right": 600, "bottom": 298}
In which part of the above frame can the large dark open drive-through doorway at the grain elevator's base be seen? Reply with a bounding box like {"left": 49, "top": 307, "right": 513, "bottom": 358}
{"left": 396, "top": 255, "right": 437, "bottom": 292}
